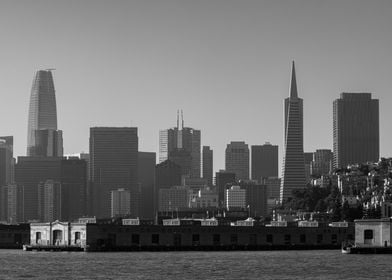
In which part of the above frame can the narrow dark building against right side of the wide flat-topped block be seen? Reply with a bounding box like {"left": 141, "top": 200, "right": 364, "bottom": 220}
{"left": 137, "top": 152, "right": 156, "bottom": 219}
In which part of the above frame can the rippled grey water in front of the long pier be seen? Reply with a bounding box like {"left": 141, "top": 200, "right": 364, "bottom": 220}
{"left": 0, "top": 250, "right": 392, "bottom": 280}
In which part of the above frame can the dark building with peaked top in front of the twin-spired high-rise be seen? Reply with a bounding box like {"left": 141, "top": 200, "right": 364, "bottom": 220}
{"left": 154, "top": 160, "right": 181, "bottom": 214}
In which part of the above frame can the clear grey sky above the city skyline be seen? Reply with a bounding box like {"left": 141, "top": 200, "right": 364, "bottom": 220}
{"left": 0, "top": 0, "right": 392, "bottom": 175}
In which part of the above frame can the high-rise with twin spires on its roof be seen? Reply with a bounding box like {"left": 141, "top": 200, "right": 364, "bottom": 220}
{"left": 159, "top": 112, "right": 201, "bottom": 178}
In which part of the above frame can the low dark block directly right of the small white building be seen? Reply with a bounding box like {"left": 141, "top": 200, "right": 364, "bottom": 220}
{"left": 240, "top": 182, "right": 268, "bottom": 218}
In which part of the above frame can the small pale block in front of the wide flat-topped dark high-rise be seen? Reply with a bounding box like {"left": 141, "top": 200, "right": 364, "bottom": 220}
{"left": 110, "top": 188, "right": 131, "bottom": 218}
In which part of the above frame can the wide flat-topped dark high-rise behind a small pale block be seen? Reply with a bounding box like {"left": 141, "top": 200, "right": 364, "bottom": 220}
{"left": 90, "top": 127, "right": 140, "bottom": 218}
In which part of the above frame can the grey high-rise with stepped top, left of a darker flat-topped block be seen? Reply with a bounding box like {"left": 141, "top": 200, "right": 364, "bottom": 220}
{"left": 225, "top": 141, "right": 249, "bottom": 180}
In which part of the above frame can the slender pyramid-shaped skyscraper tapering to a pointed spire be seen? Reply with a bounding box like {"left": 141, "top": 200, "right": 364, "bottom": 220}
{"left": 280, "top": 61, "right": 306, "bottom": 203}
